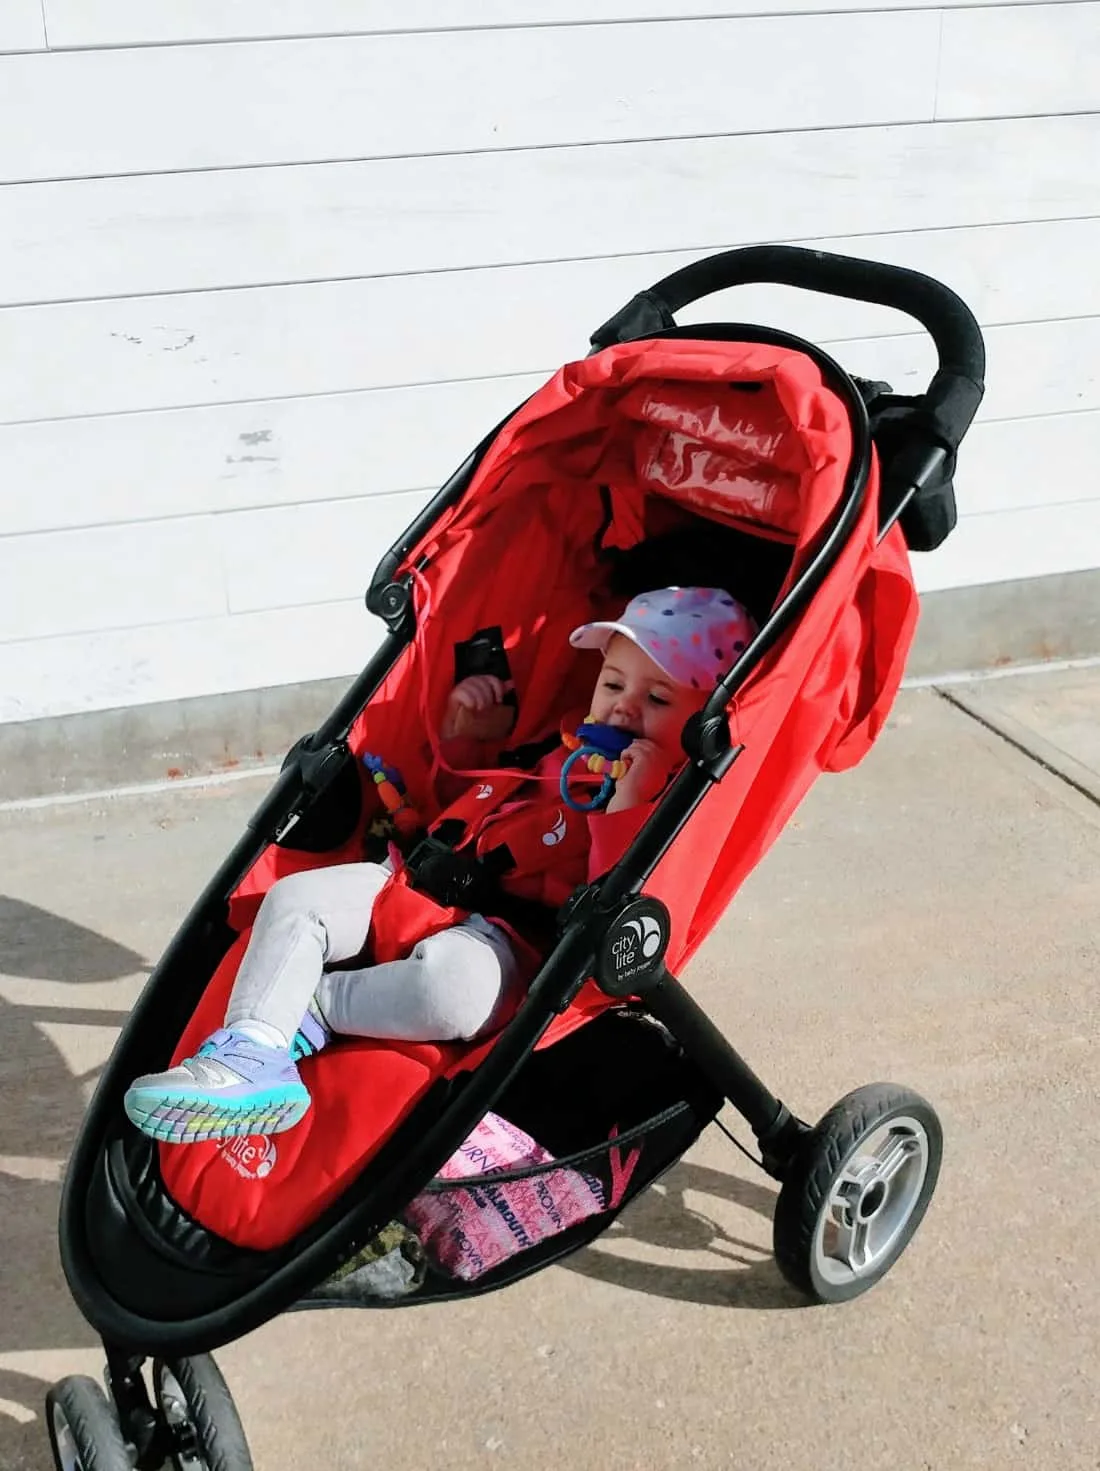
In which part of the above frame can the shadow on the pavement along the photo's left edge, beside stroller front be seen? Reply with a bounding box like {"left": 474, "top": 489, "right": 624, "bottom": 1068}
{"left": 0, "top": 894, "right": 149, "bottom": 1471}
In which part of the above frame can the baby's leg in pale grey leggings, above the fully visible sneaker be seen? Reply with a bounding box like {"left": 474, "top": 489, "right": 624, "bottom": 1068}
{"left": 225, "top": 863, "right": 390, "bottom": 1047}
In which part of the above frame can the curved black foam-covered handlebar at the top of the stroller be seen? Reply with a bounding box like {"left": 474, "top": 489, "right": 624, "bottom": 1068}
{"left": 591, "top": 246, "right": 985, "bottom": 447}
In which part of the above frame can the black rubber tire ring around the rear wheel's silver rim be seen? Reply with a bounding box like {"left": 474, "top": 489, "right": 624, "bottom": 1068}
{"left": 772, "top": 1083, "right": 943, "bottom": 1302}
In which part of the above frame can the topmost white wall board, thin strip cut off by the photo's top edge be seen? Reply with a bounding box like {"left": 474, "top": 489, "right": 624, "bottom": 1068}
{"left": 44, "top": 0, "right": 1041, "bottom": 49}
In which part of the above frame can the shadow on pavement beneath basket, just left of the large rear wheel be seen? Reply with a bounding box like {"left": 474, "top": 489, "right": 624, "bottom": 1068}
{"left": 562, "top": 1161, "right": 806, "bottom": 1311}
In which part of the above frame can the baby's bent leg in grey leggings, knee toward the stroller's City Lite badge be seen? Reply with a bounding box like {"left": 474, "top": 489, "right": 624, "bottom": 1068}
{"left": 316, "top": 915, "right": 519, "bottom": 1041}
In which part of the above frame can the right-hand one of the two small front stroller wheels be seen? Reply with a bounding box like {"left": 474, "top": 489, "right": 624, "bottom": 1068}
{"left": 153, "top": 1353, "right": 253, "bottom": 1471}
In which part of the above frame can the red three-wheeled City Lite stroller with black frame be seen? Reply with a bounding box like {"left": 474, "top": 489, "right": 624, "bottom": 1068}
{"left": 47, "top": 247, "right": 984, "bottom": 1471}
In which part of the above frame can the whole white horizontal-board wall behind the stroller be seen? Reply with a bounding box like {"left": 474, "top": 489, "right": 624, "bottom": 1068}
{"left": 0, "top": 0, "right": 1100, "bottom": 721}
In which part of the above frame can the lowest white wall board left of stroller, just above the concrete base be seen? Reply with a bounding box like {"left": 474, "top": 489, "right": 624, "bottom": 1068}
{"left": 0, "top": 599, "right": 385, "bottom": 724}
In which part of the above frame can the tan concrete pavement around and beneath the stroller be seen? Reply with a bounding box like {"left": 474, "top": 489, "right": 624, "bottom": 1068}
{"left": 0, "top": 668, "right": 1100, "bottom": 1471}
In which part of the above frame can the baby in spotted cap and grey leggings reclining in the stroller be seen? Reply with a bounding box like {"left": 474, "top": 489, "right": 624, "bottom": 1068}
{"left": 125, "top": 587, "right": 754, "bottom": 1143}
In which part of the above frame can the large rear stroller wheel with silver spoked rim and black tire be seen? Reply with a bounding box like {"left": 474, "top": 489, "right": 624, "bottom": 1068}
{"left": 772, "top": 1083, "right": 943, "bottom": 1302}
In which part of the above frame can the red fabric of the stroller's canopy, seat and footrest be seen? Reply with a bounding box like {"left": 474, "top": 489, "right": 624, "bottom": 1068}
{"left": 160, "top": 338, "right": 918, "bottom": 1249}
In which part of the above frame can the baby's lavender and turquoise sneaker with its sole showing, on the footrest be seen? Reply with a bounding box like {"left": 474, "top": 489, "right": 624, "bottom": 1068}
{"left": 124, "top": 1028, "right": 309, "bottom": 1144}
